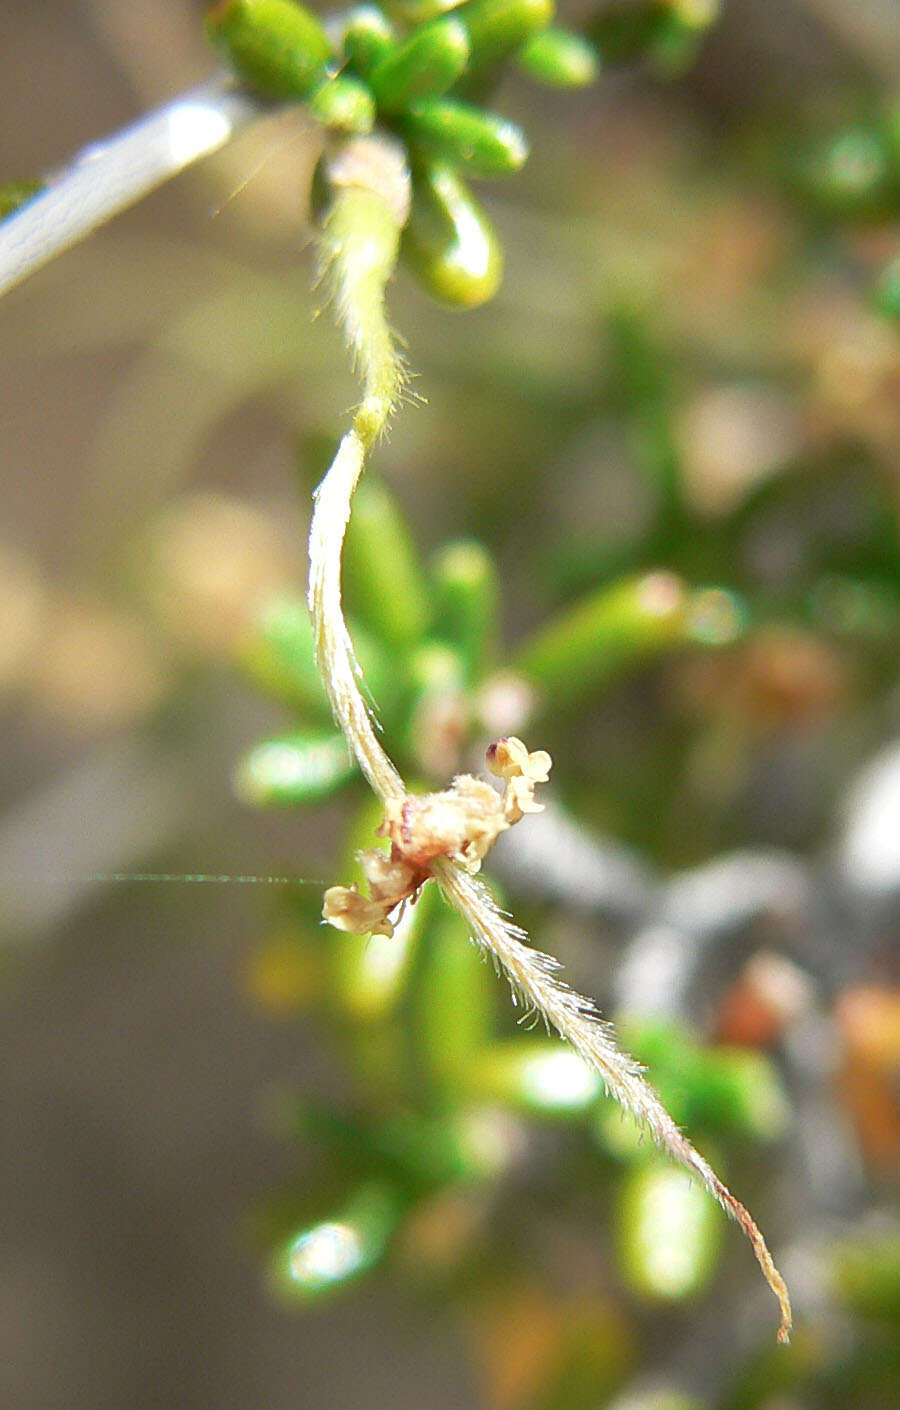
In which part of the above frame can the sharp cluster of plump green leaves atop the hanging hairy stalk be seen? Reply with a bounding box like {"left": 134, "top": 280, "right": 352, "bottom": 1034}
{"left": 207, "top": 0, "right": 715, "bottom": 307}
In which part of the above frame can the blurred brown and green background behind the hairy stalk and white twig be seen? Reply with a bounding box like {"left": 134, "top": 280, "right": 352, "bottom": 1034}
{"left": 0, "top": 0, "right": 900, "bottom": 1410}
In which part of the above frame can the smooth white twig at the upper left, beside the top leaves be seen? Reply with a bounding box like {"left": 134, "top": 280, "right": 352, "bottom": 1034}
{"left": 0, "top": 73, "right": 268, "bottom": 293}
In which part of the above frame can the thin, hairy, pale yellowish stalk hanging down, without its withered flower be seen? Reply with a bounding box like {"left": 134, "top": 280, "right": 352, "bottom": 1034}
{"left": 309, "top": 138, "right": 791, "bottom": 1342}
